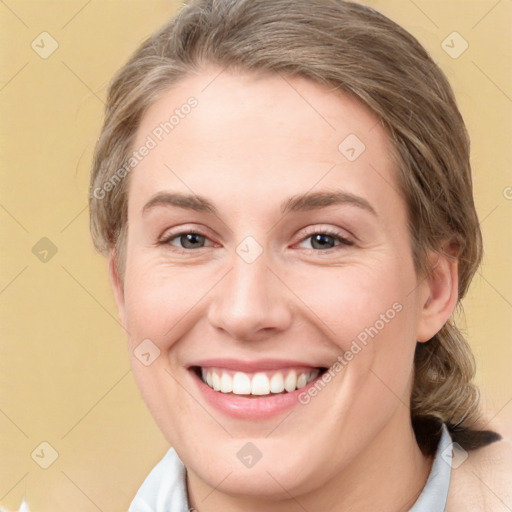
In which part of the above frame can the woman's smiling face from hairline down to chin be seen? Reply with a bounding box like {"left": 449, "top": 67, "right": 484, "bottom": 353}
{"left": 113, "top": 68, "right": 434, "bottom": 496}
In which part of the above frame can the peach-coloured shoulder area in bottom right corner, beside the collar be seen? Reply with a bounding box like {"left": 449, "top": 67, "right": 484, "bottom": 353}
{"left": 446, "top": 428, "right": 512, "bottom": 512}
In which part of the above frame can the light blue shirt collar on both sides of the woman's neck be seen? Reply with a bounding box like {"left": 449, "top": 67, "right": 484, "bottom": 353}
{"left": 128, "top": 424, "right": 452, "bottom": 512}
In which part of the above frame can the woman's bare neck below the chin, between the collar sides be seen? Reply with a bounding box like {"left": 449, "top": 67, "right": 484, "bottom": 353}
{"left": 187, "top": 407, "right": 432, "bottom": 512}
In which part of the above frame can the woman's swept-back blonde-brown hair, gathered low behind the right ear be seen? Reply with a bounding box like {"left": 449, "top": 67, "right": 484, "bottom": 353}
{"left": 90, "top": 0, "right": 498, "bottom": 454}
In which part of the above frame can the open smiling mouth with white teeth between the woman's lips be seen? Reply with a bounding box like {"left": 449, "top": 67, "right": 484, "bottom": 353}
{"left": 191, "top": 366, "right": 327, "bottom": 396}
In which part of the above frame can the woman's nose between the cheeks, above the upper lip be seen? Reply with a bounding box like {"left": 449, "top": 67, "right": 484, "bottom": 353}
{"left": 208, "top": 247, "right": 292, "bottom": 341}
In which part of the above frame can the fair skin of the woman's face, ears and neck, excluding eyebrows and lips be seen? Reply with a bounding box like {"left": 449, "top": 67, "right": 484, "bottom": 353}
{"left": 110, "top": 67, "right": 457, "bottom": 512}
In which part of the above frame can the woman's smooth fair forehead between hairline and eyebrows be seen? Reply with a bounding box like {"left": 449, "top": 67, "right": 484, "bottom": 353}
{"left": 130, "top": 68, "right": 397, "bottom": 214}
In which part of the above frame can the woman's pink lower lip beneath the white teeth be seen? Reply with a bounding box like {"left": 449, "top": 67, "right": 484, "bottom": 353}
{"left": 189, "top": 370, "right": 322, "bottom": 420}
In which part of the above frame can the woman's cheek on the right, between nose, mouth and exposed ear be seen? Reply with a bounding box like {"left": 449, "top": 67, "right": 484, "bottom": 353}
{"left": 290, "top": 257, "right": 417, "bottom": 402}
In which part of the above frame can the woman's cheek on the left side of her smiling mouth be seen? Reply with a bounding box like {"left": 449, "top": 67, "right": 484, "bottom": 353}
{"left": 125, "top": 257, "right": 206, "bottom": 440}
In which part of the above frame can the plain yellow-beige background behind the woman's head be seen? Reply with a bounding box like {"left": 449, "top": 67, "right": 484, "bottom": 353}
{"left": 0, "top": 0, "right": 512, "bottom": 512}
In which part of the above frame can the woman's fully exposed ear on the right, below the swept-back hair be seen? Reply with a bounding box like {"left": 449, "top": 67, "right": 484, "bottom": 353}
{"left": 416, "top": 247, "right": 459, "bottom": 342}
